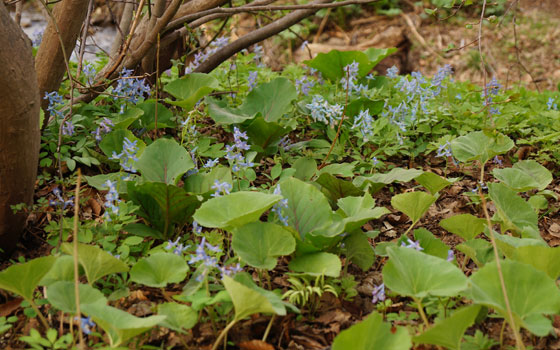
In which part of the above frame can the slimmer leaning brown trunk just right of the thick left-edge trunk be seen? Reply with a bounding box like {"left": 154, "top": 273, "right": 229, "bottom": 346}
{"left": 35, "top": 0, "right": 89, "bottom": 109}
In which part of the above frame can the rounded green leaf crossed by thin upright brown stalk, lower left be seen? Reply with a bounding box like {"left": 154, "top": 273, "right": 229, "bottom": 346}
{"left": 47, "top": 281, "right": 107, "bottom": 315}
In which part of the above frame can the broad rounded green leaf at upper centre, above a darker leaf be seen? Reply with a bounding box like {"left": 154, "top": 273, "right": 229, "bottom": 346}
{"left": 241, "top": 77, "right": 297, "bottom": 122}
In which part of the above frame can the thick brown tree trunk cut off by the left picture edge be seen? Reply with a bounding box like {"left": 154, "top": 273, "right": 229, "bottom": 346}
{"left": 0, "top": 1, "right": 40, "bottom": 256}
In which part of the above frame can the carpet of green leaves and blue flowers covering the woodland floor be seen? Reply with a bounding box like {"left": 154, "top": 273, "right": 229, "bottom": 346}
{"left": 0, "top": 0, "right": 560, "bottom": 350}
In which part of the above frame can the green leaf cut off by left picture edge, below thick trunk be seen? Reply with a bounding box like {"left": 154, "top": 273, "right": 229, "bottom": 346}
{"left": 0, "top": 256, "right": 56, "bottom": 300}
